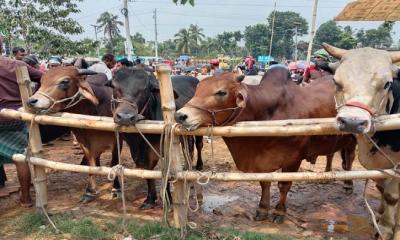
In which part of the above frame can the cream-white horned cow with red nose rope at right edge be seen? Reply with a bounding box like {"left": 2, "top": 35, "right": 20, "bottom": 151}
{"left": 323, "top": 44, "right": 400, "bottom": 239}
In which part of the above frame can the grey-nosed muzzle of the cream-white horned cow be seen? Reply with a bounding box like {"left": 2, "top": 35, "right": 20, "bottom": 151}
{"left": 336, "top": 107, "right": 372, "bottom": 134}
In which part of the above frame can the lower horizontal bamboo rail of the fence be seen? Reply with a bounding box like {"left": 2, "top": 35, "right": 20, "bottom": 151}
{"left": 13, "top": 154, "right": 395, "bottom": 182}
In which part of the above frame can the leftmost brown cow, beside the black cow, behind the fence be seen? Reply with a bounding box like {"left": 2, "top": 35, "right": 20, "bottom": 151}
{"left": 28, "top": 67, "right": 119, "bottom": 202}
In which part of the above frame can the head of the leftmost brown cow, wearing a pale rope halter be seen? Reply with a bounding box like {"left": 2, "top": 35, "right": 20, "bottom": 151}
{"left": 27, "top": 66, "right": 98, "bottom": 112}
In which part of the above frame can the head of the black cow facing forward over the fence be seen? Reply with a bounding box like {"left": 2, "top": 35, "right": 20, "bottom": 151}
{"left": 111, "top": 68, "right": 159, "bottom": 125}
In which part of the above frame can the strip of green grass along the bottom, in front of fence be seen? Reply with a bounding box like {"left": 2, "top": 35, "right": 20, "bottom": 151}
{"left": 12, "top": 213, "right": 310, "bottom": 240}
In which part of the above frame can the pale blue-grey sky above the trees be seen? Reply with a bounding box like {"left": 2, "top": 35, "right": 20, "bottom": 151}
{"left": 72, "top": 0, "right": 400, "bottom": 43}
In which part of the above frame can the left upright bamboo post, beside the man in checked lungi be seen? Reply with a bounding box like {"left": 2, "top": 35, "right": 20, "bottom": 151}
{"left": 15, "top": 66, "right": 47, "bottom": 209}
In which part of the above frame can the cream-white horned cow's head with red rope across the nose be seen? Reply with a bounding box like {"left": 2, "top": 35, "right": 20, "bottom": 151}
{"left": 323, "top": 44, "right": 400, "bottom": 133}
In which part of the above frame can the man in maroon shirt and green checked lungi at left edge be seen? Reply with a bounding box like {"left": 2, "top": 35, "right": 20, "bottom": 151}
{"left": 0, "top": 36, "right": 42, "bottom": 207}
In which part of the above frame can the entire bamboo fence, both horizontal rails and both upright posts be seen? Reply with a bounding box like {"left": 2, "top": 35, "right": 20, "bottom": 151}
{"left": 0, "top": 65, "right": 400, "bottom": 237}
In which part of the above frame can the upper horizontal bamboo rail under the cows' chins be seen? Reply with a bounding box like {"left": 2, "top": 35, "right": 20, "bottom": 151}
{"left": 0, "top": 109, "right": 400, "bottom": 137}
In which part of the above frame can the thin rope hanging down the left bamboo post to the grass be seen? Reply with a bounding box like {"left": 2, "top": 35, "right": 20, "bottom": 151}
{"left": 25, "top": 115, "right": 62, "bottom": 234}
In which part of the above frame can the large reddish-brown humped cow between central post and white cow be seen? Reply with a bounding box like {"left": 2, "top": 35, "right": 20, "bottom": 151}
{"left": 175, "top": 68, "right": 355, "bottom": 222}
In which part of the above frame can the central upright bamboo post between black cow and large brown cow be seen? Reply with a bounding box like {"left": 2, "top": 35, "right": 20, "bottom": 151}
{"left": 157, "top": 64, "right": 188, "bottom": 232}
